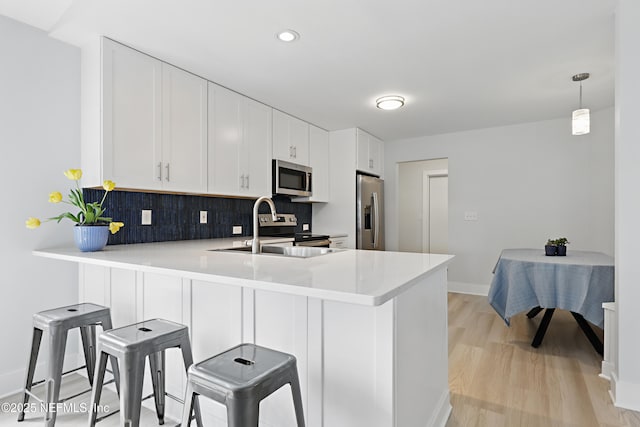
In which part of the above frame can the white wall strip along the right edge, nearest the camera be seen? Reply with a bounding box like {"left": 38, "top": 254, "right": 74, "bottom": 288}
{"left": 611, "top": 0, "right": 640, "bottom": 411}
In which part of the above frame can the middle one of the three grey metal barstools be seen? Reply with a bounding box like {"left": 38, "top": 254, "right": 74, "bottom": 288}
{"left": 89, "top": 319, "right": 202, "bottom": 427}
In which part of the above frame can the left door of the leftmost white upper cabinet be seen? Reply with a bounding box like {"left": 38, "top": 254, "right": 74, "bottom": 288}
{"left": 102, "top": 39, "right": 162, "bottom": 189}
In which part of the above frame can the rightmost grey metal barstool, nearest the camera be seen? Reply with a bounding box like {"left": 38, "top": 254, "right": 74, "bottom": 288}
{"left": 181, "top": 344, "right": 304, "bottom": 427}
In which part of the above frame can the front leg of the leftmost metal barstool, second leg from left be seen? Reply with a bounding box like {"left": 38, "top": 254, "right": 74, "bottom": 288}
{"left": 44, "top": 326, "right": 67, "bottom": 427}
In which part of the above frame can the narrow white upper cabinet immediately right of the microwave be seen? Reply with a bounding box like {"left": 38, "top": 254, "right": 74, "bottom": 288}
{"left": 292, "top": 125, "right": 329, "bottom": 202}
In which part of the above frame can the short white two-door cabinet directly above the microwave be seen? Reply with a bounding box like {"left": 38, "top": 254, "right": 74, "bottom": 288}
{"left": 273, "top": 110, "right": 309, "bottom": 166}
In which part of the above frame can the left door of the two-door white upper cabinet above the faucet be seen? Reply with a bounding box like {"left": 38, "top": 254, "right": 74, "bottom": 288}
{"left": 208, "top": 83, "right": 246, "bottom": 195}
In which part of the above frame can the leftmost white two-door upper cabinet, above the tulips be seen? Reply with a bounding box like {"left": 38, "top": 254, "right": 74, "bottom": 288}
{"left": 102, "top": 39, "right": 207, "bottom": 192}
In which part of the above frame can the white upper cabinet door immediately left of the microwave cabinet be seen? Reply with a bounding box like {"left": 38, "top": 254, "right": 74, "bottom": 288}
{"left": 240, "top": 97, "right": 272, "bottom": 197}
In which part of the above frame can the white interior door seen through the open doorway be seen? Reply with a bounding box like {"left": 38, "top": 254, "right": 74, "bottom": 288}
{"left": 422, "top": 171, "right": 449, "bottom": 254}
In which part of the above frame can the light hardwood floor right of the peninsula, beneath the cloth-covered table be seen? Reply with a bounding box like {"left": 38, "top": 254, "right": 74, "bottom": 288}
{"left": 447, "top": 293, "right": 640, "bottom": 427}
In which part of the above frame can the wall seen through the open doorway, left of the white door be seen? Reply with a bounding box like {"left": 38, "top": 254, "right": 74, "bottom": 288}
{"left": 397, "top": 159, "right": 449, "bottom": 252}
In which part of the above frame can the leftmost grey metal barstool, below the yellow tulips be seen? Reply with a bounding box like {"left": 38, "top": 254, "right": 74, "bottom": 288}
{"left": 18, "top": 303, "right": 118, "bottom": 427}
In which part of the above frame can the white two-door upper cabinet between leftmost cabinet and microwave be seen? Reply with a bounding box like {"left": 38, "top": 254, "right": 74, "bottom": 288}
{"left": 208, "top": 83, "right": 272, "bottom": 196}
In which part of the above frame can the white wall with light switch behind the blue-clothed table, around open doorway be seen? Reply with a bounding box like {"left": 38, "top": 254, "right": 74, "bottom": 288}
{"left": 385, "top": 108, "right": 614, "bottom": 290}
